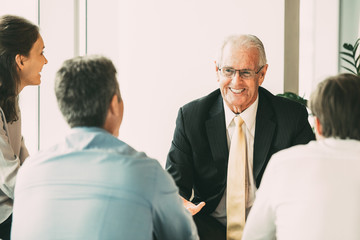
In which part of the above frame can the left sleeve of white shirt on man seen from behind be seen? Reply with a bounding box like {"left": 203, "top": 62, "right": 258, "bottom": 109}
{"left": 242, "top": 160, "right": 276, "bottom": 240}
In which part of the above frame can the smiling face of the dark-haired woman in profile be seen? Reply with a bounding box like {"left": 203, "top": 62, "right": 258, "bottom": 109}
{"left": 17, "top": 35, "right": 48, "bottom": 92}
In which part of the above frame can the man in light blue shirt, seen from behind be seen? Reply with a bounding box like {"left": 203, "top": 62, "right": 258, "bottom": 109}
{"left": 12, "top": 56, "right": 198, "bottom": 240}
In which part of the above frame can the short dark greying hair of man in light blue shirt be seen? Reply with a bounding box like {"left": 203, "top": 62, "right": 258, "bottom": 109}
{"left": 55, "top": 56, "right": 121, "bottom": 127}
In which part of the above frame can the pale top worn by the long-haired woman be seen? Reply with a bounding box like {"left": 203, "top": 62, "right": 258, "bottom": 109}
{"left": 0, "top": 108, "right": 29, "bottom": 223}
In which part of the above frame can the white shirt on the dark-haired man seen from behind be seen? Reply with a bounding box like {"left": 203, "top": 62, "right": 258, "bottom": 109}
{"left": 243, "top": 138, "right": 360, "bottom": 240}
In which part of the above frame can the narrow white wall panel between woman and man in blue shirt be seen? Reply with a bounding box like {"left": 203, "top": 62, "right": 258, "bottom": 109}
{"left": 40, "top": 0, "right": 75, "bottom": 153}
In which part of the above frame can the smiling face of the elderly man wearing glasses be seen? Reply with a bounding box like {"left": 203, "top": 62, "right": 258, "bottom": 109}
{"left": 215, "top": 43, "right": 268, "bottom": 113}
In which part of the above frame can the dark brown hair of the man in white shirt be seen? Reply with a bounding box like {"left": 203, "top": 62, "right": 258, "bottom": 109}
{"left": 309, "top": 74, "right": 360, "bottom": 140}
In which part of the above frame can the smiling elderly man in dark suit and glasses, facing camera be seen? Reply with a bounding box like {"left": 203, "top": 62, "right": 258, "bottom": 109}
{"left": 166, "top": 35, "right": 315, "bottom": 239}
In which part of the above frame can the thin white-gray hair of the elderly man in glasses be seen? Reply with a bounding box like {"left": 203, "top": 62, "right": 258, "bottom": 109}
{"left": 218, "top": 34, "right": 267, "bottom": 66}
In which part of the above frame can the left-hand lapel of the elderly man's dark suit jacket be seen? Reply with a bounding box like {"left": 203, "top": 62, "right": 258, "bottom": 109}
{"left": 205, "top": 95, "right": 229, "bottom": 164}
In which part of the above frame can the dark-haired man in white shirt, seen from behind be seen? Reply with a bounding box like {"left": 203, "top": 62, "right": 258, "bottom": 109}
{"left": 243, "top": 74, "right": 360, "bottom": 240}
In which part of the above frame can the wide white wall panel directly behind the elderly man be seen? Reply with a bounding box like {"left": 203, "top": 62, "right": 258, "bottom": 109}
{"left": 111, "top": 0, "right": 284, "bottom": 165}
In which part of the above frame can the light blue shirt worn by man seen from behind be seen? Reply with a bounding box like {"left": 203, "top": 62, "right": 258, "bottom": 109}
{"left": 12, "top": 127, "right": 198, "bottom": 240}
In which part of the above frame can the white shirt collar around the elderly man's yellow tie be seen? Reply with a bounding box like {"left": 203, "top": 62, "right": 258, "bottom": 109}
{"left": 223, "top": 94, "right": 259, "bottom": 136}
